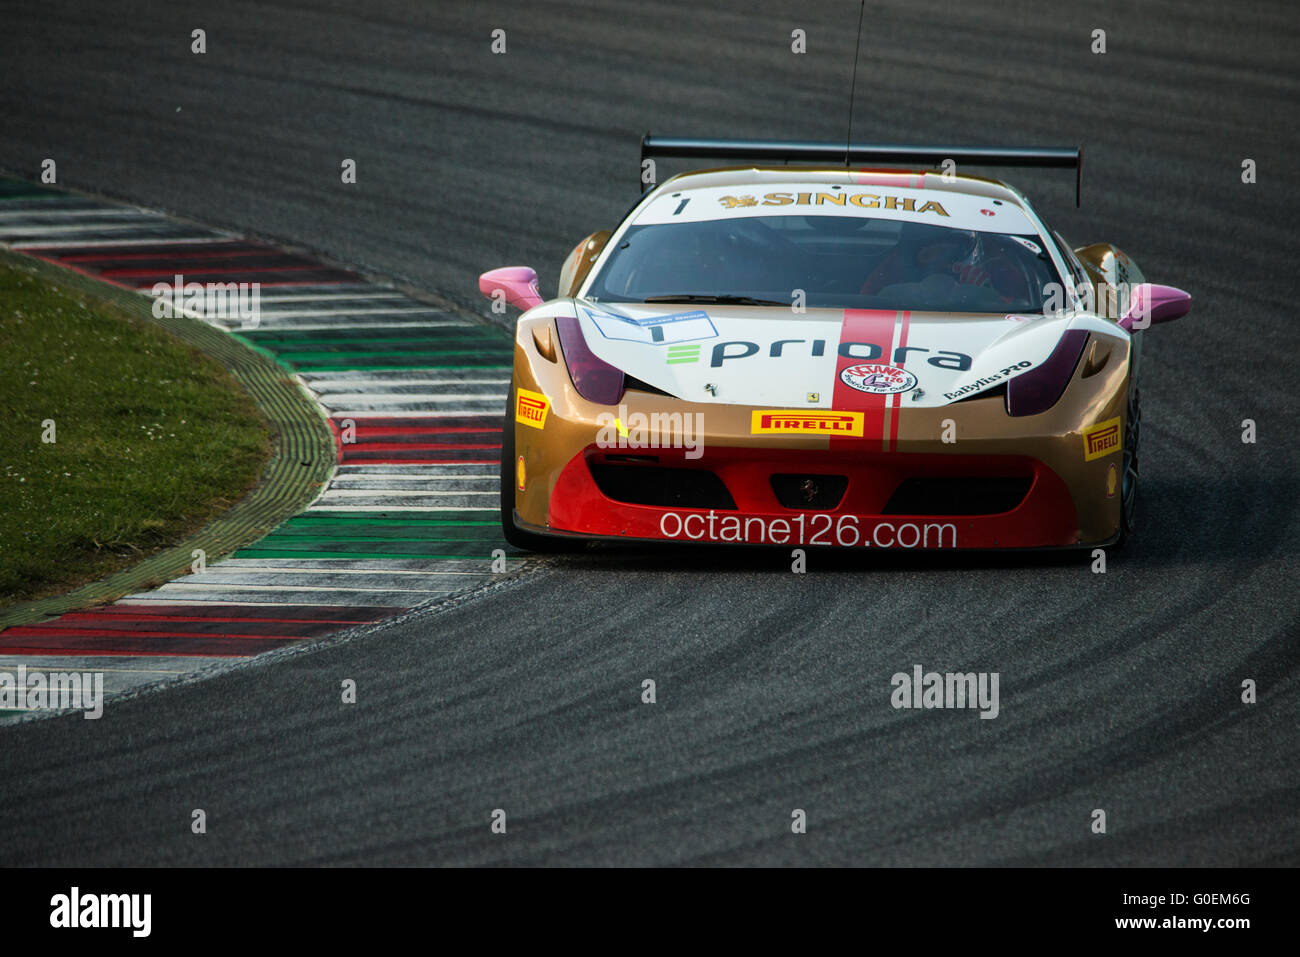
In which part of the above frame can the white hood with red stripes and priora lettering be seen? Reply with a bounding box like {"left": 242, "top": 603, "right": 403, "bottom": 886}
{"left": 564, "top": 299, "right": 1126, "bottom": 408}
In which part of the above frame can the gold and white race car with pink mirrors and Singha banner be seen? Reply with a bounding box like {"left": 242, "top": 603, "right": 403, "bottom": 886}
{"left": 480, "top": 135, "right": 1191, "bottom": 550}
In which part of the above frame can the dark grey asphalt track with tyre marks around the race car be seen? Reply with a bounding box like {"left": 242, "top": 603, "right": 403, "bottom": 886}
{"left": 0, "top": 3, "right": 1300, "bottom": 866}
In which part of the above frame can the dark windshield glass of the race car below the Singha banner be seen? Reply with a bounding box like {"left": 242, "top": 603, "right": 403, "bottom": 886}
{"left": 586, "top": 215, "right": 1060, "bottom": 313}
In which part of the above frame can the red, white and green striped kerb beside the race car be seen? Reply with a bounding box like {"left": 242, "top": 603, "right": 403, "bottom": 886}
{"left": 0, "top": 181, "right": 514, "bottom": 694}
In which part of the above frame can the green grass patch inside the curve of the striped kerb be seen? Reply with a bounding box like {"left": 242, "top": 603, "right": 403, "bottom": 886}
{"left": 0, "top": 264, "right": 270, "bottom": 606}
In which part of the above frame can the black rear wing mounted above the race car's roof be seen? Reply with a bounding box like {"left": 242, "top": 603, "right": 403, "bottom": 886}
{"left": 641, "top": 133, "right": 1083, "bottom": 207}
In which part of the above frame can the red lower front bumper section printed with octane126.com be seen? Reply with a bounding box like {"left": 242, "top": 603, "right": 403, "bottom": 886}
{"left": 533, "top": 446, "right": 1080, "bottom": 549}
